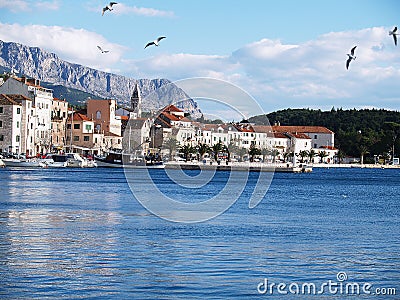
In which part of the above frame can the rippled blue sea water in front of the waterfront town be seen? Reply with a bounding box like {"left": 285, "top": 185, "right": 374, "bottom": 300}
{"left": 0, "top": 168, "right": 400, "bottom": 299}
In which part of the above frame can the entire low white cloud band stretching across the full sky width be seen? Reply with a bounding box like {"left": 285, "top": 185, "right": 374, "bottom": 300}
{"left": 0, "top": 21, "right": 400, "bottom": 111}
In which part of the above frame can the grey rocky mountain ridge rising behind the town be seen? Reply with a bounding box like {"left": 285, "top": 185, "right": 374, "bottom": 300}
{"left": 0, "top": 40, "right": 201, "bottom": 117}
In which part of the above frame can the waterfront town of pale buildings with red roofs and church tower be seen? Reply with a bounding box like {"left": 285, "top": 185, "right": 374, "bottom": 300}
{"left": 0, "top": 75, "right": 338, "bottom": 165}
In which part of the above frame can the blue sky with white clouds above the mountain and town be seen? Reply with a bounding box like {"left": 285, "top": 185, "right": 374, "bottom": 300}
{"left": 0, "top": 0, "right": 400, "bottom": 118}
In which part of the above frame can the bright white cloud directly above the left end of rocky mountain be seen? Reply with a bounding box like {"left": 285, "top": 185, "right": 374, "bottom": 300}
{"left": 0, "top": 23, "right": 126, "bottom": 71}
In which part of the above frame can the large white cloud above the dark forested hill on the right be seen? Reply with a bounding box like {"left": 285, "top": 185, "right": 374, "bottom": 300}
{"left": 128, "top": 27, "right": 400, "bottom": 111}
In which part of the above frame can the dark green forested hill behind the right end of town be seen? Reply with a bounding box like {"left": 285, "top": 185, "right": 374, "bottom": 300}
{"left": 249, "top": 108, "right": 400, "bottom": 158}
